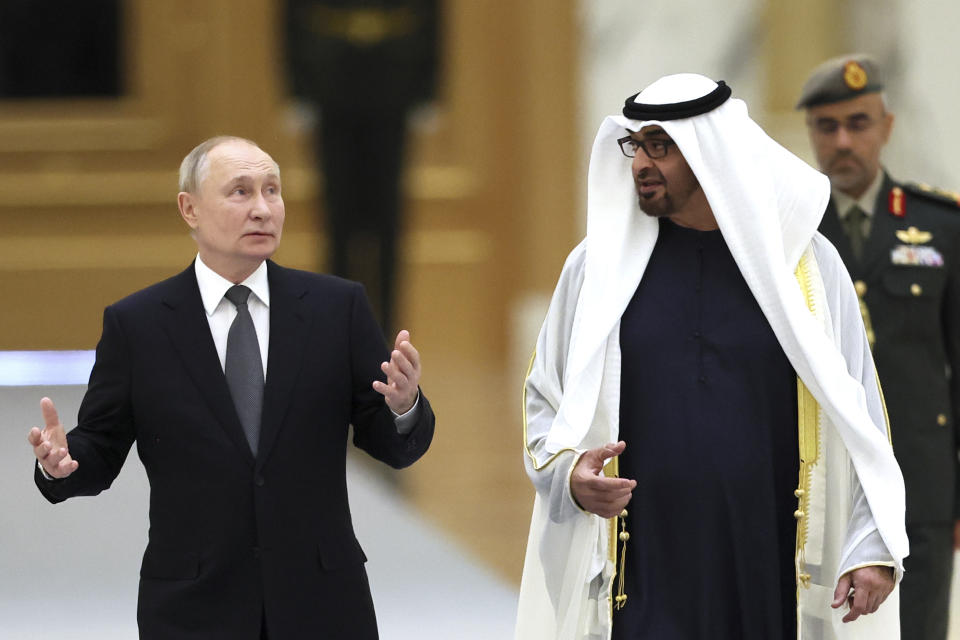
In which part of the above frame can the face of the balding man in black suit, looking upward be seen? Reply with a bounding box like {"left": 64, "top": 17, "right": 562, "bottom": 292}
{"left": 180, "top": 141, "right": 285, "bottom": 279}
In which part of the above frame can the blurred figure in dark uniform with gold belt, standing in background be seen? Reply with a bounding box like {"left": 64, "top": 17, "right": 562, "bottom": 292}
{"left": 285, "top": 0, "right": 439, "bottom": 334}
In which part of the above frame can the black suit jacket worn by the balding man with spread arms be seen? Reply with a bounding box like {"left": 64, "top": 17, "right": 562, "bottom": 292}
{"left": 35, "top": 262, "right": 434, "bottom": 640}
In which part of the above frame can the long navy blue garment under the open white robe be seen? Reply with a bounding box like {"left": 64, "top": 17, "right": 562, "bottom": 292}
{"left": 613, "top": 220, "right": 799, "bottom": 640}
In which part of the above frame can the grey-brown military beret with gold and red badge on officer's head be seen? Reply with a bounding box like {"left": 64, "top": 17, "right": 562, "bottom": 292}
{"left": 796, "top": 53, "right": 883, "bottom": 109}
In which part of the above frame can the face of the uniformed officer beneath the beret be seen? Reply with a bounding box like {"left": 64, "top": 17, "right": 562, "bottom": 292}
{"left": 807, "top": 93, "right": 893, "bottom": 198}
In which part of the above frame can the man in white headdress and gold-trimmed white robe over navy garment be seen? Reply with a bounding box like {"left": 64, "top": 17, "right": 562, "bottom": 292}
{"left": 516, "top": 74, "right": 907, "bottom": 640}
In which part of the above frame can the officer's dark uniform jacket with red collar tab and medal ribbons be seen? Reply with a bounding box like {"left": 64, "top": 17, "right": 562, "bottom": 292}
{"left": 820, "top": 174, "right": 960, "bottom": 524}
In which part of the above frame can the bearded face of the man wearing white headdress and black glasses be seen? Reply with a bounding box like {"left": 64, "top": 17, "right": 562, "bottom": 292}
{"left": 630, "top": 126, "right": 701, "bottom": 217}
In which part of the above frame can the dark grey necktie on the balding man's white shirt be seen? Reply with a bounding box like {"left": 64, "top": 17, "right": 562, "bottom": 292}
{"left": 223, "top": 284, "right": 263, "bottom": 457}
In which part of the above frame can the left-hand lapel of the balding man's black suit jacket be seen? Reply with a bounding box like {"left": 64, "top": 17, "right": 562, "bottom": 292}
{"left": 161, "top": 265, "right": 253, "bottom": 466}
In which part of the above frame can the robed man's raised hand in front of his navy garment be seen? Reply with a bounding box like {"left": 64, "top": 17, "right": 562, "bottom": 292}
{"left": 570, "top": 440, "right": 637, "bottom": 518}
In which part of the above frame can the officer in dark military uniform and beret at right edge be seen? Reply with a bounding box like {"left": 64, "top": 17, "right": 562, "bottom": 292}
{"left": 797, "top": 55, "right": 960, "bottom": 640}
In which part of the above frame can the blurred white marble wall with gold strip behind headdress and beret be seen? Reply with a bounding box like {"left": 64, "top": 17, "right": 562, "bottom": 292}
{"left": 579, "top": 0, "right": 960, "bottom": 194}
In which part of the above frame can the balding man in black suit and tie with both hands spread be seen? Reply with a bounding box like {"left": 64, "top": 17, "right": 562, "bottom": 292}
{"left": 29, "top": 137, "right": 434, "bottom": 640}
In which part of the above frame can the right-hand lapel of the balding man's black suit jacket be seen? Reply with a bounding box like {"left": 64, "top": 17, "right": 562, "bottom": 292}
{"left": 257, "top": 261, "right": 309, "bottom": 468}
